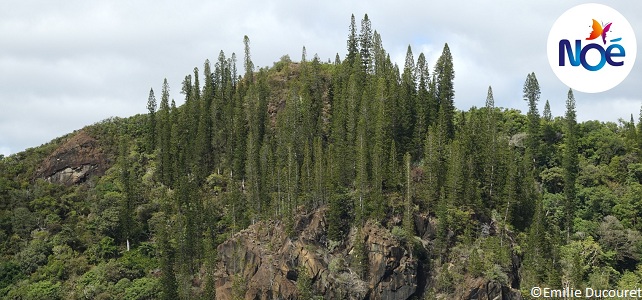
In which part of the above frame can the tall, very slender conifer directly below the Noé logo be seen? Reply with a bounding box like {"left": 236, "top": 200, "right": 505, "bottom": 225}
{"left": 563, "top": 89, "right": 579, "bottom": 238}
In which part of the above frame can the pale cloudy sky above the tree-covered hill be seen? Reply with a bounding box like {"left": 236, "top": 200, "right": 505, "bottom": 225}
{"left": 0, "top": 0, "right": 642, "bottom": 155}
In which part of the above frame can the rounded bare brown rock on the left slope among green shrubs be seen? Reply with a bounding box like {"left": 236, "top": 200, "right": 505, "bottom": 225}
{"left": 36, "top": 131, "right": 110, "bottom": 186}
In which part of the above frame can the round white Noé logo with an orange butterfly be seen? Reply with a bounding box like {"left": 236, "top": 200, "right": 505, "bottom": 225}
{"left": 547, "top": 3, "right": 637, "bottom": 93}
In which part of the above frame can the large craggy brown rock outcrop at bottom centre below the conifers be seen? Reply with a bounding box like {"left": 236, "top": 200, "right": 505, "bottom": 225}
{"left": 216, "top": 210, "right": 418, "bottom": 300}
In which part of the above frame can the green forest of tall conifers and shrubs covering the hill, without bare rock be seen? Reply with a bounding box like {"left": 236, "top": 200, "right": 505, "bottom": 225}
{"left": 0, "top": 15, "right": 642, "bottom": 299}
